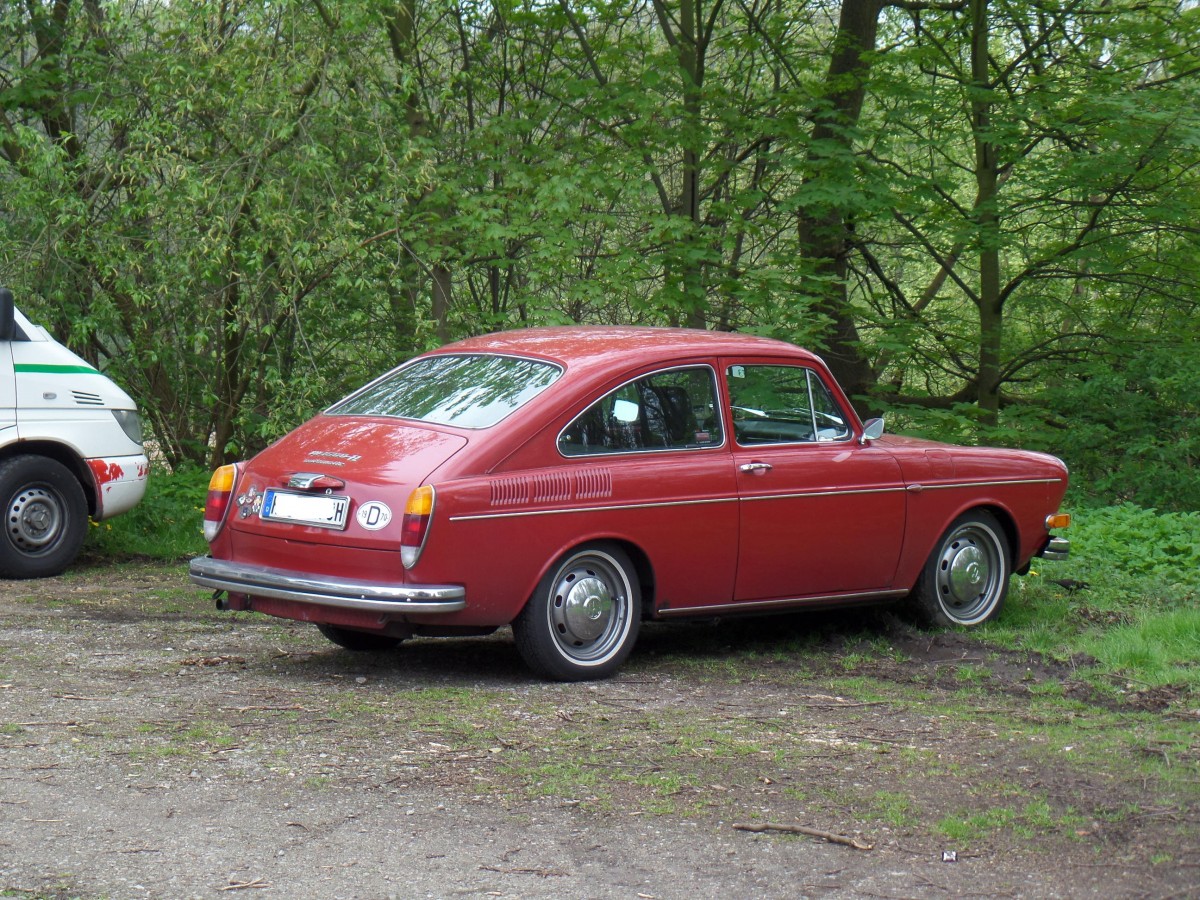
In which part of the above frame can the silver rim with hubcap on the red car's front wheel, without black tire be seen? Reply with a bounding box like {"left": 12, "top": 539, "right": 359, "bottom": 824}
{"left": 936, "top": 522, "right": 1008, "bottom": 625}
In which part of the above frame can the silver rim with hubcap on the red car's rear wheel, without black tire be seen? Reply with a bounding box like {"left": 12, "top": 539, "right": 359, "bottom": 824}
{"left": 547, "top": 552, "right": 632, "bottom": 666}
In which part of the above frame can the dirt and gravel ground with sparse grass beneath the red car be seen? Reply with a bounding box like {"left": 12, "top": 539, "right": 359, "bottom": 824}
{"left": 0, "top": 563, "right": 1200, "bottom": 900}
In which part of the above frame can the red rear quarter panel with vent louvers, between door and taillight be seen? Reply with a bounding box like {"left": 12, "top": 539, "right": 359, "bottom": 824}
{"left": 409, "top": 449, "right": 737, "bottom": 624}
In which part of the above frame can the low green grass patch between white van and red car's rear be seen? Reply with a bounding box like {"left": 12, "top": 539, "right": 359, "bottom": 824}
{"left": 83, "top": 468, "right": 210, "bottom": 560}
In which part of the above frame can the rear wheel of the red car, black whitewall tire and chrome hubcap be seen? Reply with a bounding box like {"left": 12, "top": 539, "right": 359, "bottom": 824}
{"left": 512, "top": 544, "right": 642, "bottom": 682}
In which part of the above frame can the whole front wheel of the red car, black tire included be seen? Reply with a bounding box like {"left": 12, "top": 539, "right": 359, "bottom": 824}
{"left": 912, "top": 510, "right": 1013, "bottom": 628}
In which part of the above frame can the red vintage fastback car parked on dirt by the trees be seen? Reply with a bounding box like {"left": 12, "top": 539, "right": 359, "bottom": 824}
{"left": 191, "top": 328, "right": 1069, "bottom": 680}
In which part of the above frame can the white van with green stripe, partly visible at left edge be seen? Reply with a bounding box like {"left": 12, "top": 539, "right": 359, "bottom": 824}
{"left": 0, "top": 288, "right": 150, "bottom": 578}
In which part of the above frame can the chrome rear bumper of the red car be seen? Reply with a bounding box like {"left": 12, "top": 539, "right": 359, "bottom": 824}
{"left": 187, "top": 557, "right": 467, "bottom": 616}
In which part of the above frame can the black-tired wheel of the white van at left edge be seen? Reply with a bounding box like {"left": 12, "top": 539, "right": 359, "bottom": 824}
{"left": 0, "top": 456, "right": 88, "bottom": 578}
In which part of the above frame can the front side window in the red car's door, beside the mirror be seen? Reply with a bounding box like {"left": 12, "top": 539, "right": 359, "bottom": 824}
{"left": 726, "top": 366, "right": 852, "bottom": 446}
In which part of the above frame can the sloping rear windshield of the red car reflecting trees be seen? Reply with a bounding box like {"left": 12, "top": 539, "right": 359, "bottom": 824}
{"left": 329, "top": 355, "right": 562, "bottom": 428}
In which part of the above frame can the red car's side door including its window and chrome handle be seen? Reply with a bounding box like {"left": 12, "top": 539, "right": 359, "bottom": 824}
{"left": 724, "top": 361, "right": 905, "bottom": 601}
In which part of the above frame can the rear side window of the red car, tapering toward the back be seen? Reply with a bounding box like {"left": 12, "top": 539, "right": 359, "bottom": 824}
{"left": 558, "top": 366, "right": 722, "bottom": 456}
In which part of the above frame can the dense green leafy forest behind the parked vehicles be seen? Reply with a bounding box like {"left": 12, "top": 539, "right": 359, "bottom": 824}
{"left": 0, "top": 0, "right": 1200, "bottom": 510}
